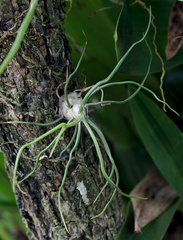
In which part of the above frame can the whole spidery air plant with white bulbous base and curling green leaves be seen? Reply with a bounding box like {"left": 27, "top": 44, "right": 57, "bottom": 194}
{"left": 0, "top": 1, "right": 177, "bottom": 232}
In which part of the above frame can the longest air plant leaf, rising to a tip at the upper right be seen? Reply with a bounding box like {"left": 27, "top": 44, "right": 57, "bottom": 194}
{"left": 80, "top": 8, "right": 152, "bottom": 108}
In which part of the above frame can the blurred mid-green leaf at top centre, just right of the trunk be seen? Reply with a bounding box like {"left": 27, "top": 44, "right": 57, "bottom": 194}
{"left": 65, "top": 0, "right": 121, "bottom": 86}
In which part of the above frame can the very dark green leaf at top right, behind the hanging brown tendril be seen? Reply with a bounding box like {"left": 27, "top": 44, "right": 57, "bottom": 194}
{"left": 116, "top": 0, "right": 183, "bottom": 74}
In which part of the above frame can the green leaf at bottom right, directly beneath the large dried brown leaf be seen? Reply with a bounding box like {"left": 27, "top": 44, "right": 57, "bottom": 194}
{"left": 116, "top": 200, "right": 180, "bottom": 240}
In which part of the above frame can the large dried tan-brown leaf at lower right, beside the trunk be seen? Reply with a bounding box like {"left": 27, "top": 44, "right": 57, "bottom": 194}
{"left": 130, "top": 168, "right": 178, "bottom": 232}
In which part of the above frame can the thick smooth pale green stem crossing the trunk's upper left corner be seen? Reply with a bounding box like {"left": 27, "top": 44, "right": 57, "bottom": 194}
{"left": 0, "top": 0, "right": 38, "bottom": 75}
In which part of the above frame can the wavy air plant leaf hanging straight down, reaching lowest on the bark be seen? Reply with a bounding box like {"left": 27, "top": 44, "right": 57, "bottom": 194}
{"left": 57, "top": 122, "right": 81, "bottom": 233}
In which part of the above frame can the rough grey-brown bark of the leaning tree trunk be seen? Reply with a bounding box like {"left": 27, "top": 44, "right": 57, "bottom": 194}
{"left": 0, "top": 0, "right": 122, "bottom": 240}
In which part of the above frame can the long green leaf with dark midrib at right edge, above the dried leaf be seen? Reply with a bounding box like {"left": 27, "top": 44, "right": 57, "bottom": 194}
{"left": 130, "top": 88, "right": 183, "bottom": 199}
